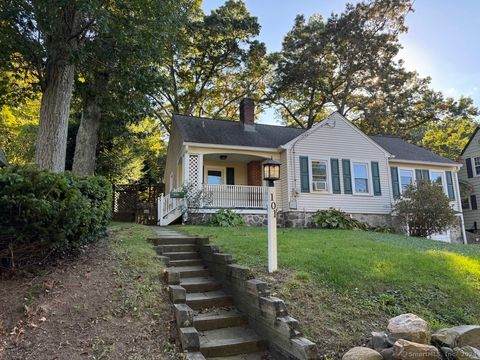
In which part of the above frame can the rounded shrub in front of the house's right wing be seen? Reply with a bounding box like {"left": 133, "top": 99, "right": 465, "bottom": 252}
{"left": 394, "top": 181, "right": 457, "bottom": 237}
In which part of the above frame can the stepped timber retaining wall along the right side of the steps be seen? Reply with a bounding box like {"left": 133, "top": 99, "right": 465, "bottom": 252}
{"left": 200, "top": 244, "right": 319, "bottom": 360}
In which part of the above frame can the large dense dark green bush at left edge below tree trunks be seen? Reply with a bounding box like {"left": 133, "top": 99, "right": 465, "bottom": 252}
{"left": 0, "top": 166, "right": 112, "bottom": 268}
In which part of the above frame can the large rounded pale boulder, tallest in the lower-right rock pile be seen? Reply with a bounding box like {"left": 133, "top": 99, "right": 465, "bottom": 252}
{"left": 387, "top": 314, "right": 430, "bottom": 344}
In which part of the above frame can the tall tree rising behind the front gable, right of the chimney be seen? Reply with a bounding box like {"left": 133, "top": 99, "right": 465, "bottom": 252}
{"left": 268, "top": 0, "right": 411, "bottom": 128}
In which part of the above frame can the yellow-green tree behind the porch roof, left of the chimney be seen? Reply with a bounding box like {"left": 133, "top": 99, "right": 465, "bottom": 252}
{"left": 151, "top": 0, "right": 268, "bottom": 131}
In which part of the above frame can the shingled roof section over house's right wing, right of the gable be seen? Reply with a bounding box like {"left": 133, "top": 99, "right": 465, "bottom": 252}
{"left": 370, "top": 135, "right": 457, "bottom": 164}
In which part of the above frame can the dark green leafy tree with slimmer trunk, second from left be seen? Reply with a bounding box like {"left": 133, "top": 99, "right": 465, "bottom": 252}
{"left": 72, "top": 0, "right": 191, "bottom": 175}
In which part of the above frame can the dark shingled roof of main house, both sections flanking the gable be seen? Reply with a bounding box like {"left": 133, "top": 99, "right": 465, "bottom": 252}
{"left": 173, "top": 114, "right": 457, "bottom": 164}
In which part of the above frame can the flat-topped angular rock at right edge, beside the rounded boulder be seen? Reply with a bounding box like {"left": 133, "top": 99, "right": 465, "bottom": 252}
{"left": 432, "top": 325, "right": 480, "bottom": 349}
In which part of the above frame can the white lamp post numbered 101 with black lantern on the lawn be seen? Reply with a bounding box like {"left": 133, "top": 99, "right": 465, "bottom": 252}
{"left": 263, "top": 159, "right": 280, "bottom": 273}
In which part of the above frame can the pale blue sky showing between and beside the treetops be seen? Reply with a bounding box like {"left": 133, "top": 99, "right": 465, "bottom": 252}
{"left": 203, "top": 0, "right": 480, "bottom": 123}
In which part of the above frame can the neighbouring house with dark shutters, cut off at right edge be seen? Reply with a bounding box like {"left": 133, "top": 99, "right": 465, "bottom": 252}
{"left": 458, "top": 128, "right": 480, "bottom": 233}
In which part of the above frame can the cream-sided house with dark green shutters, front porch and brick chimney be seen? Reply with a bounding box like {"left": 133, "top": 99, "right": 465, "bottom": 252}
{"left": 159, "top": 99, "right": 463, "bottom": 241}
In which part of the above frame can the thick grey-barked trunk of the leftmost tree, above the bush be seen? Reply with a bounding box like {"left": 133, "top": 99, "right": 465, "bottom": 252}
{"left": 35, "top": 61, "right": 75, "bottom": 172}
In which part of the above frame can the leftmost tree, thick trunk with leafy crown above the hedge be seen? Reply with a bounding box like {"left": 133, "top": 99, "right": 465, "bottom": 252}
{"left": 0, "top": 0, "right": 106, "bottom": 172}
